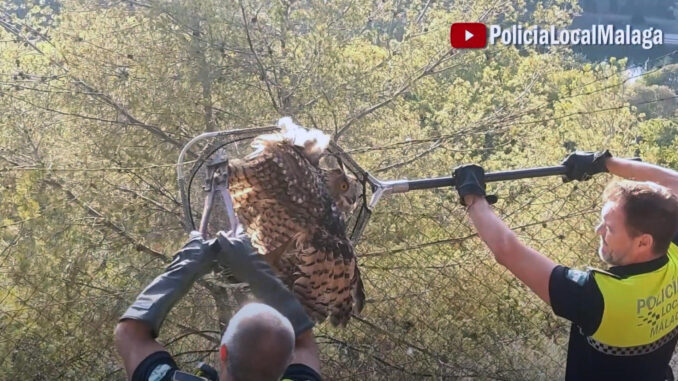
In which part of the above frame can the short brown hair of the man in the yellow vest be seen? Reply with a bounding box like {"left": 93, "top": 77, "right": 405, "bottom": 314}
{"left": 603, "top": 180, "right": 678, "bottom": 255}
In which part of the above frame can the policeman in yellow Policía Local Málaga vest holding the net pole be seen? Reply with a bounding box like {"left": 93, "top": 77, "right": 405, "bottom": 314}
{"left": 454, "top": 151, "right": 678, "bottom": 381}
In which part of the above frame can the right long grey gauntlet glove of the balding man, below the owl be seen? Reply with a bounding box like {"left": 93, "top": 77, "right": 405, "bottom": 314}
{"left": 210, "top": 231, "right": 314, "bottom": 336}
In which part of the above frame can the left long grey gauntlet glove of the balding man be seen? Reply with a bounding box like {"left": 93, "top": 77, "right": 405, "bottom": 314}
{"left": 120, "top": 231, "right": 218, "bottom": 338}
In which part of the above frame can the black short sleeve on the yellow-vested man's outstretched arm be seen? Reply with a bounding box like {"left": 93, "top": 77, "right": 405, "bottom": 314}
{"left": 549, "top": 266, "right": 605, "bottom": 335}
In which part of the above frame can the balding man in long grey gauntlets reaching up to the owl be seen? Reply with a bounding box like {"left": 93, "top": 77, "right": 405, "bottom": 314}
{"left": 115, "top": 232, "right": 320, "bottom": 381}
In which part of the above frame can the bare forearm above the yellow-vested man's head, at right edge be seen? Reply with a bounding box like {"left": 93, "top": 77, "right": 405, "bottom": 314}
{"left": 605, "top": 157, "right": 678, "bottom": 194}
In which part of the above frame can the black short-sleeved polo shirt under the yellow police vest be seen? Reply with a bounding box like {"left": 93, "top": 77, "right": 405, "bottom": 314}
{"left": 549, "top": 240, "right": 678, "bottom": 381}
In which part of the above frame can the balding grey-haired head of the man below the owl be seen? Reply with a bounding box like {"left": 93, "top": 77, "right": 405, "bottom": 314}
{"left": 220, "top": 303, "right": 294, "bottom": 381}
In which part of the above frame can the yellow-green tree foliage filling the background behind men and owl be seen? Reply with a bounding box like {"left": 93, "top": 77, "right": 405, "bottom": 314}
{"left": 0, "top": 0, "right": 678, "bottom": 380}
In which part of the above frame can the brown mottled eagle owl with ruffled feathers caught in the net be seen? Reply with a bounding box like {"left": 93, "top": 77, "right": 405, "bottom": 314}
{"left": 229, "top": 118, "right": 365, "bottom": 325}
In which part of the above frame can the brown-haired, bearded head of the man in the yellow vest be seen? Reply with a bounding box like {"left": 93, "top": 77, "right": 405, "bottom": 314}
{"left": 596, "top": 180, "right": 678, "bottom": 266}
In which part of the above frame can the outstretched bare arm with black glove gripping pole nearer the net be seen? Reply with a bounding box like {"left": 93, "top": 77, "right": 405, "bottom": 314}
{"left": 454, "top": 165, "right": 556, "bottom": 304}
